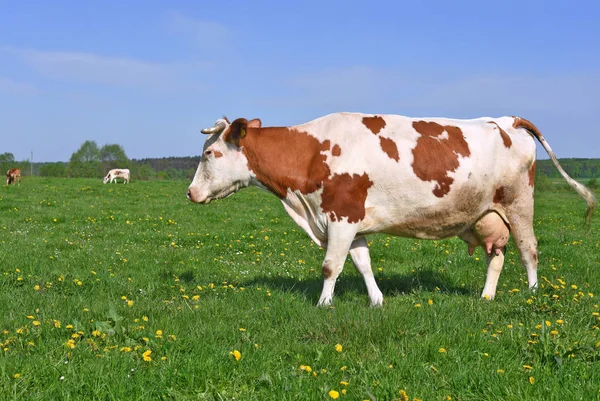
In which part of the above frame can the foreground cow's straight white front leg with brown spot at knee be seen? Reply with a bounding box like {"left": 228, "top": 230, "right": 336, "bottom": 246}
{"left": 318, "top": 223, "right": 356, "bottom": 306}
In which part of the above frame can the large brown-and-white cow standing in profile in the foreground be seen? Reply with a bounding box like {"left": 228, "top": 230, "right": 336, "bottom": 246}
{"left": 187, "top": 113, "right": 596, "bottom": 306}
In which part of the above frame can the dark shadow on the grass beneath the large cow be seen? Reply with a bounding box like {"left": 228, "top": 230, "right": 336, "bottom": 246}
{"left": 239, "top": 270, "right": 472, "bottom": 300}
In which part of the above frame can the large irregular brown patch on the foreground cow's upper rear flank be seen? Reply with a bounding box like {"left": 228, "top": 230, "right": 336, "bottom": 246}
{"left": 412, "top": 121, "right": 471, "bottom": 198}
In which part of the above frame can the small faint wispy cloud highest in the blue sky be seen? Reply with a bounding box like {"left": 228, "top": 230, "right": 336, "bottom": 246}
{"left": 167, "top": 11, "right": 233, "bottom": 49}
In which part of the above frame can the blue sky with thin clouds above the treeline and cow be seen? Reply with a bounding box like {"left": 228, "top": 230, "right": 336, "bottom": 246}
{"left": 0, "top": 0, "right": 600, "bottom": 161}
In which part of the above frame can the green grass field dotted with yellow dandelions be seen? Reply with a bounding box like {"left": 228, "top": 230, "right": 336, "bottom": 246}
{"left": 0, "top": 178, "right": 600, "bottom": 401}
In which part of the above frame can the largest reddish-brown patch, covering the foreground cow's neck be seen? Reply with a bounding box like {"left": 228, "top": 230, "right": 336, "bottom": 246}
{"left": 240, "top": 127, "right": 331, "bottom": 198}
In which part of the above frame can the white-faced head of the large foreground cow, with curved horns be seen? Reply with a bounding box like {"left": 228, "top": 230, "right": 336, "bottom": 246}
{"left": 187, "top": 118, "right": 261, "bottom": 204}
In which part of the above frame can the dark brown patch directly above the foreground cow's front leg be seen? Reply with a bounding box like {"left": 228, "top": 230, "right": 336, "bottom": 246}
{"left": 321, "top": 173, "right": 373, "bottom": 223}
